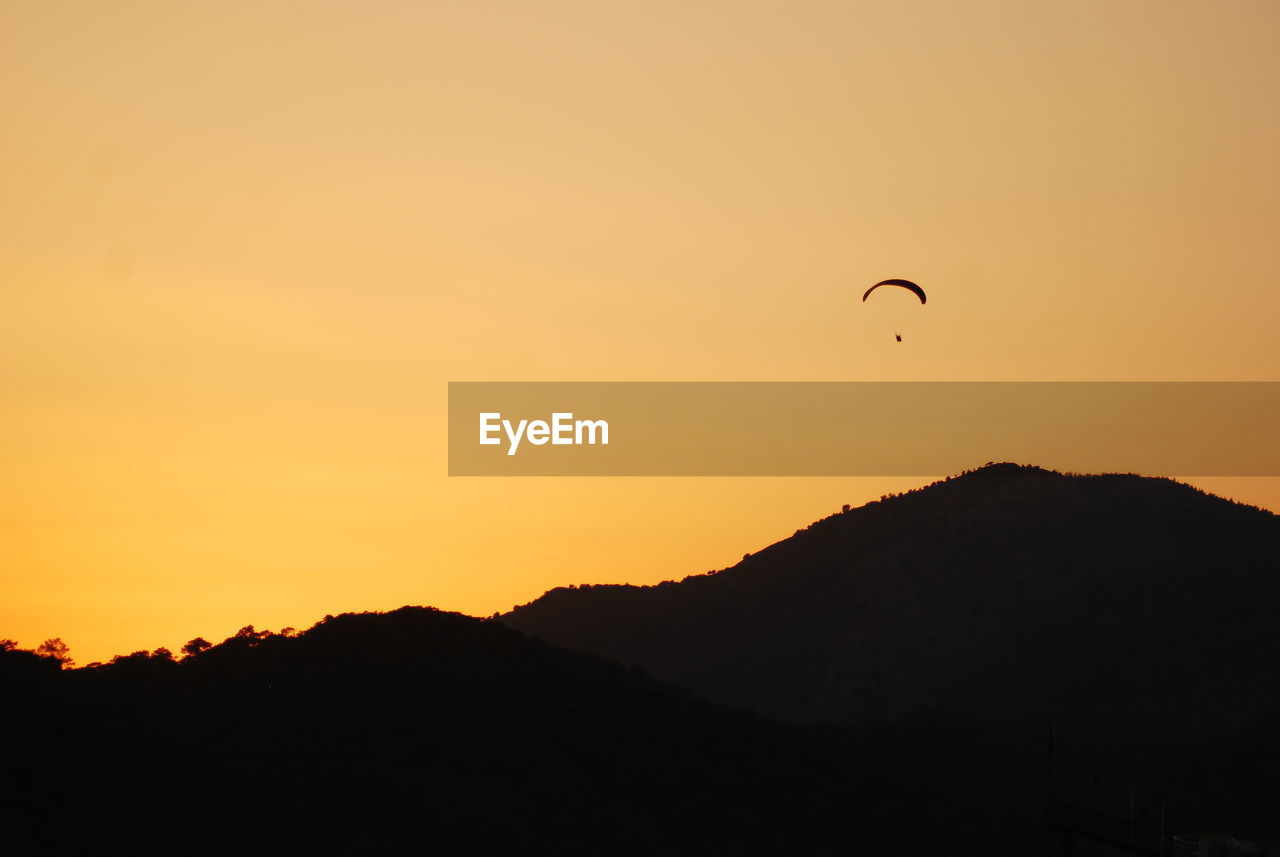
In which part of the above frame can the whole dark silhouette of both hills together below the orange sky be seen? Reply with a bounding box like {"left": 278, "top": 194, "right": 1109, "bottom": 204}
{"left": 10, "top": 464, "right": 1280, "bottom": 854}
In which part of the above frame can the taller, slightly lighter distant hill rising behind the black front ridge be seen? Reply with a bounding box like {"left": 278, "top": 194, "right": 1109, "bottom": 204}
{"left": 500, "top": 464, "right": 1280, "bottom": 742}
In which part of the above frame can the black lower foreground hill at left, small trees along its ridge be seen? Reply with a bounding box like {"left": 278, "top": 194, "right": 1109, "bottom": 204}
{"left": 0, "top": 608, "right": 963, "bottom": 854}
